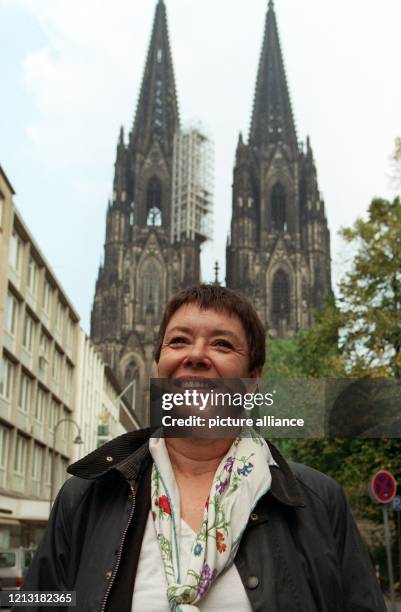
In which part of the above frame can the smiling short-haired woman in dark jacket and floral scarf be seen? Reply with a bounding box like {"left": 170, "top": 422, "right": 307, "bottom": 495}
{"left": 19, "top": 285, "right": 385, "bottom": 612}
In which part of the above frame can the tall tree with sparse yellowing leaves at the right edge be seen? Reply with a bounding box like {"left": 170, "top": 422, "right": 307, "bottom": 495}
{"left": 340, "top": 198, "right": 401, "bottom": 378}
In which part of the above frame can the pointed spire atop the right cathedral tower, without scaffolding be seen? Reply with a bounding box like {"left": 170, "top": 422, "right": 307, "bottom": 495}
{"left": 249, "top": 0, "right": 297, "bottom": 146}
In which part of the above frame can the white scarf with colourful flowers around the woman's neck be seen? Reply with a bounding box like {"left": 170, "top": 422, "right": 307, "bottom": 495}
{"left": 149, "top": 432, "right": 275, "bottom": 612}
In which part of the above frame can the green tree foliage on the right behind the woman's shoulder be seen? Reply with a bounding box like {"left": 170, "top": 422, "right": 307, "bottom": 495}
{"left": 264, "top": 198, "right": 401, "bottom": 522}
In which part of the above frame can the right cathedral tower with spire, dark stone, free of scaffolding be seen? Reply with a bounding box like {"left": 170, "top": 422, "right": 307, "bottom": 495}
{"left": 226, "top": 0, "right": 331, "bottom": 337}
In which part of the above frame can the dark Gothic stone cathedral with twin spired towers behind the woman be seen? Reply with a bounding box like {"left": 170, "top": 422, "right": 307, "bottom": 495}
{"left": 91, "top": 0, "right": 331, "bottom": 424}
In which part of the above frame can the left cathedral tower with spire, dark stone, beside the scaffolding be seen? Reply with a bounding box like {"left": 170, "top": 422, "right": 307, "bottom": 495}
{"left": 91, "top": 0, "right": 202, "bottom": 424}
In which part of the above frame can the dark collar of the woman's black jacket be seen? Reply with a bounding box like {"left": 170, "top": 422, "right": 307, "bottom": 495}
{"left": 67, "top": 429, "right": 305, "bottom": 508}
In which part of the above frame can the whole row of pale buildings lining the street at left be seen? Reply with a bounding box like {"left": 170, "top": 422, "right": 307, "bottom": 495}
{"left": 0, "top": 166, "right": 140, "bottom": 548}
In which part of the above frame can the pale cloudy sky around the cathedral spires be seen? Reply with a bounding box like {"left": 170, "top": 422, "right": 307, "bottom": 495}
{"left": 0, "top": 0, "right": 401, "bottom": 331}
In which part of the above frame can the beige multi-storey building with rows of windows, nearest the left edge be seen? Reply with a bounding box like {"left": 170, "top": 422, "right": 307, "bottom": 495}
{"left": 0, "top": 167, "right": 79, "bottom": 546}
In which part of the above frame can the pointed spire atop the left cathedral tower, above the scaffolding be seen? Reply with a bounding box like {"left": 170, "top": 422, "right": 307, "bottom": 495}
{"left": 131, "top": 0, "right": 179, "bottom": 150}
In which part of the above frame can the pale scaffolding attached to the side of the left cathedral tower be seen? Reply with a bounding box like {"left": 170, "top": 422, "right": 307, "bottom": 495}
{"left": 171, "top": 127, "right": 214, "bottom": 242}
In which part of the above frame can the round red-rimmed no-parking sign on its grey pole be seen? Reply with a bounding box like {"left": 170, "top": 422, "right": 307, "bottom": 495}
{"left": 370, "top": 470, "right": 397, "bottom": 612}
